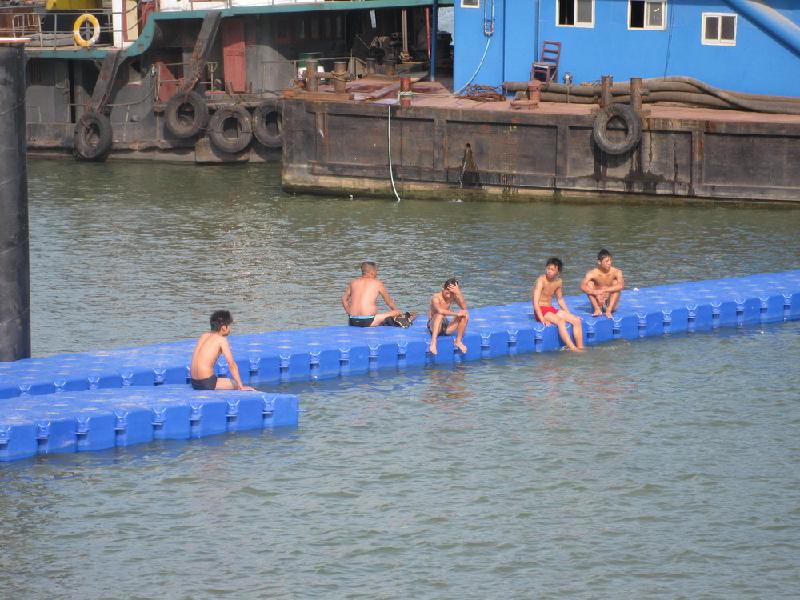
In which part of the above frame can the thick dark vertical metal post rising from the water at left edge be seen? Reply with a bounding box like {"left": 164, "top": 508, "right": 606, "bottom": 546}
{"left": 0, "top": 38, "right": 31, "bottom": 361}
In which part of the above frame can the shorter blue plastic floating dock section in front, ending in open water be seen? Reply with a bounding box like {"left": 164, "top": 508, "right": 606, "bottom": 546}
{"left": 0, "top": 385, "right": 299, "bottom": 462}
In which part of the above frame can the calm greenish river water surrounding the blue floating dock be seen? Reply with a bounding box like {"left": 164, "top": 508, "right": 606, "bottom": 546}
{"left": 0, "top": 161, "right": 800, "bottom": 598}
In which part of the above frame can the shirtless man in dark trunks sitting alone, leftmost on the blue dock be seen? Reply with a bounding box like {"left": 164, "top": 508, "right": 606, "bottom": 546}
{"left": 190, "top": 310, "right": 255, "bottom": 392}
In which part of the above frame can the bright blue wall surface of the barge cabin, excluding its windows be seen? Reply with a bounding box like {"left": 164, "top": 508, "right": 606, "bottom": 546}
{"left": 454, "top": 0, "right": 800, "bottom": 96}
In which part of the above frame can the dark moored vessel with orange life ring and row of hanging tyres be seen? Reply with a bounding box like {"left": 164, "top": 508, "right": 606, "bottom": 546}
{"left": 0, "top": 0, "right": 450, "bottom": 163}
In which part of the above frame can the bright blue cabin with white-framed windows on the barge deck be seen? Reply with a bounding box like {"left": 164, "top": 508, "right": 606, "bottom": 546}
{"left": 454, "top": 0, "right": 800, "bottom": 96}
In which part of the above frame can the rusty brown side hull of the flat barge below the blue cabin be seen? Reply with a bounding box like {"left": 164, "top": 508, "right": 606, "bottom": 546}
{"left": 282, "top": 97, "right": 800, "bottom": 202}
